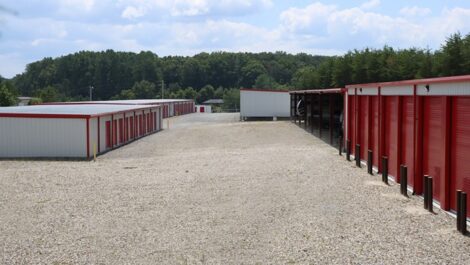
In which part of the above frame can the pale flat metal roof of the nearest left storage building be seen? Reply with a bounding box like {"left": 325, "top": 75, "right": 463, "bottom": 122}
{"left": 0, "top": 104, "right": 156, "bottom": 116}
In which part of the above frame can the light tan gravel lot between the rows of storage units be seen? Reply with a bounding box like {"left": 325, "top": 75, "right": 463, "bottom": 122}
{"left": 0, "top": 114, "right": 470, "bottom": 264}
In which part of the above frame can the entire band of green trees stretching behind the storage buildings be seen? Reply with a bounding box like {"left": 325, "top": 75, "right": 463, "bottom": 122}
{"left": 0, "top": 33, "right": 470, "bottom": 108}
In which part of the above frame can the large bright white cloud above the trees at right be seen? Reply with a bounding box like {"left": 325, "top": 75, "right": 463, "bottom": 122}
{"left": 280, "top": 1, "right": 470, "bottom": 50}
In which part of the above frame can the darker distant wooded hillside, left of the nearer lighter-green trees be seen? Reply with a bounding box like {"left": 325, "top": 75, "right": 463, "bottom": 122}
{"left": 13, "top": 50, "right": 328, "bottom": 99}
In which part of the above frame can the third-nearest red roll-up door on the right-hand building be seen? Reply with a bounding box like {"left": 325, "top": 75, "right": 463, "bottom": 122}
{"left": 401, "top": 96, "right": 415, "bottom": 187}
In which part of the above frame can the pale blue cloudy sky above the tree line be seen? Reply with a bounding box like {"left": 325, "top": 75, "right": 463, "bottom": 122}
{"left": 0, "top": 0, "right": 470, "bottom": 77}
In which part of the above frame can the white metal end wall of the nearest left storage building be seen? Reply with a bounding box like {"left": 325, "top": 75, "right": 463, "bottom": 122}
{"left": 0, "top": 117, "right": 86, "bottom": 158}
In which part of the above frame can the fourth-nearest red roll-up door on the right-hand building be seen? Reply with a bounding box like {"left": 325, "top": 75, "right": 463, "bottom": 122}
{"left": 383, "top": 96, "right": 399, "bottom": 180}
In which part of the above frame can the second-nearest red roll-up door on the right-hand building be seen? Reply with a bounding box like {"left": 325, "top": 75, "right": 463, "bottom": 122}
{"left": 423, "top": 97, "right": 446, "bottom": 202}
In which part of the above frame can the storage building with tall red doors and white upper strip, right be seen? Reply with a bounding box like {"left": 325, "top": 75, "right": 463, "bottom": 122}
{"left": 345, "top": 75, "right": 470, "bottom": 213}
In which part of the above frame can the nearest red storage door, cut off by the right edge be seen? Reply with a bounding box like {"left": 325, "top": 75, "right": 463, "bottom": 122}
{"left": 450, "top": 97, "right": 470, "bottom": 216}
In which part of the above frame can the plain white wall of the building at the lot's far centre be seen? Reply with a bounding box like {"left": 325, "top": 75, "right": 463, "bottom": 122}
{"left": 240, "top": 90, "right": 290, "bottom": 117}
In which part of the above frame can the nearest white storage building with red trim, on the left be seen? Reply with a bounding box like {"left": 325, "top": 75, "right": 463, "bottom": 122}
{"left": 0, "top": 104, "right": 163, "bottom": 159}
